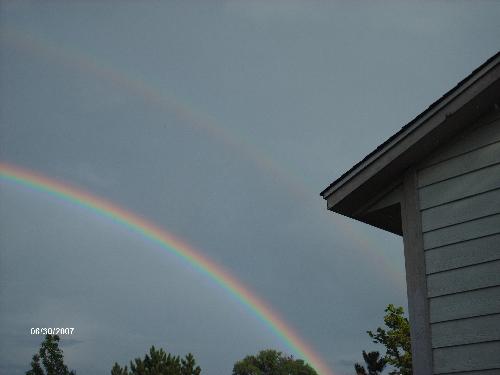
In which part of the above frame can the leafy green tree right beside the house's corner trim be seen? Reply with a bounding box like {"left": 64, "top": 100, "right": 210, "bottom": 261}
{"left": 367, "top": 304, "right": 412, "bottom": 375}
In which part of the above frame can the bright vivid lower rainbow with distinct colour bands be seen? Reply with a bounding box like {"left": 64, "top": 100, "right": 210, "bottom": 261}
{"left": 0, "top": 162, "right": 333, "bottom": 375}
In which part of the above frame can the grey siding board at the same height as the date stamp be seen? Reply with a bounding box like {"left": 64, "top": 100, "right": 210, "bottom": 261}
{"left": 431, "top": 314, "right": 500, "bottom": 348}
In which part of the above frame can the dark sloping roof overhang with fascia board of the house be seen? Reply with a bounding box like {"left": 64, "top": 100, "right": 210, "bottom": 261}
{"left": 320, "top": 52, "right": 500, "bottom": 231}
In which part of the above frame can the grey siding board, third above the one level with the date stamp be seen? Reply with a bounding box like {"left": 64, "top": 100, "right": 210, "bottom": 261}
{"left": 425, "top": 234, "right": 500, "bottom": 274}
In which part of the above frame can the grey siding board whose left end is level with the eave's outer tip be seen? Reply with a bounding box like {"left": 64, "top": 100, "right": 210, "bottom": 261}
{"left": 419, "top": 164, "right": 500, "bottom": 210}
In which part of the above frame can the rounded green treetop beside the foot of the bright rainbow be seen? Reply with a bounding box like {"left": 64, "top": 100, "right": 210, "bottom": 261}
{"left": 233, "top": 349, "right": 317, "bottom": 375}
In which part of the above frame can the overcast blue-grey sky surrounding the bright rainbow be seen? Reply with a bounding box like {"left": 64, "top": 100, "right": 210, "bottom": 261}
{"left": 0, "top": 0, "right": 500, "bottom": 375}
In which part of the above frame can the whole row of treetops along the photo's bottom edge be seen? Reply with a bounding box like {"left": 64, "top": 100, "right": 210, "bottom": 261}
{"left": 26, "top": 304, "right": 412, "bottom": 375}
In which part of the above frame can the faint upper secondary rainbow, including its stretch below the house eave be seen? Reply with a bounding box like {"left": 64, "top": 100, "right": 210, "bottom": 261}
{"left": 2, "top": 27, "right": 406, "bottom": 294}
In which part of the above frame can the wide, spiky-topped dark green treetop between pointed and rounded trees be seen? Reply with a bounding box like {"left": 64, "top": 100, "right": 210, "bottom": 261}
{"left": 111, "top": 346, "right": 201, "bottom": 375}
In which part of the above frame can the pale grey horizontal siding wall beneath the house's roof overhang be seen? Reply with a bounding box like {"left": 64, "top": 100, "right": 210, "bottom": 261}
{"left": 418, "top": 111, "right": 500, "bottom": 375}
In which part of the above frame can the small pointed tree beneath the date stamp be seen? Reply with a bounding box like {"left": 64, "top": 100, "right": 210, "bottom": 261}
{"left": 26, "top": 335, "right": 75, "bottom": 375}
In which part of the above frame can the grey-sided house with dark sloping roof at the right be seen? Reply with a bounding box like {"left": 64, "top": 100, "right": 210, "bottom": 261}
{"left": 321, "top": 53, "right": 500, "bottom": 375}
